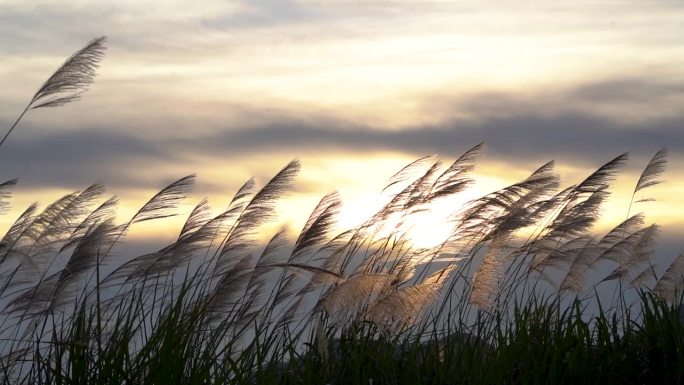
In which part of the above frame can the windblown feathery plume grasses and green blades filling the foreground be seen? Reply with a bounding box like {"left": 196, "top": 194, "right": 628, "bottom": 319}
{"left": 0, "top": 35, "right": 684, "bottom": 384}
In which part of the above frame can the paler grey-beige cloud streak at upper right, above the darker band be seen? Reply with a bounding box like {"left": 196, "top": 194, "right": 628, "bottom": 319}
{"left": 436, "top": 74, "right": 684, "bottom": 129}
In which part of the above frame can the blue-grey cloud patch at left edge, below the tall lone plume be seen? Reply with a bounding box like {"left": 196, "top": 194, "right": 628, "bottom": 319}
{"left": 0, "top": 126, "right": 175, "bottom": 189}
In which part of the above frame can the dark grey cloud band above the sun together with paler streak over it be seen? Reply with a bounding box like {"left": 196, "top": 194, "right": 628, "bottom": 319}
{"left": 180, "top": 78, "right": 684, "bottom": 167}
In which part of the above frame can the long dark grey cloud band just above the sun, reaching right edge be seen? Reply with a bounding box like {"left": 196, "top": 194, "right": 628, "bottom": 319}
{"left": 199, "top": 114, "right": 684, "bottom": 165}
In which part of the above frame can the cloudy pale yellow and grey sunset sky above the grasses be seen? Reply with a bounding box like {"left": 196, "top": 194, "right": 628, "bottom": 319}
{"left": 0, "top": 0, "right": 684, "bottom": 258}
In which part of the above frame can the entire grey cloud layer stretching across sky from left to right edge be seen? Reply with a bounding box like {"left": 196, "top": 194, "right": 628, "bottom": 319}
{"left": 0, "top": 76, "right": 684, "bottom": 195}
